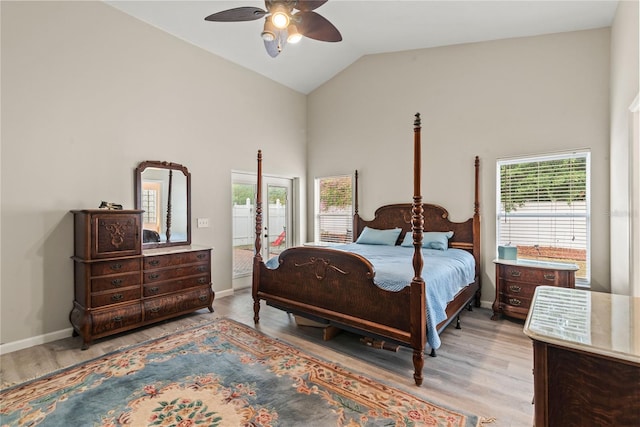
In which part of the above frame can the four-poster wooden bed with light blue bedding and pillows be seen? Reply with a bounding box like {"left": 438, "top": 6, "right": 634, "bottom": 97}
{"left": 252, "top": 114, "right": 480, "bottom": 385}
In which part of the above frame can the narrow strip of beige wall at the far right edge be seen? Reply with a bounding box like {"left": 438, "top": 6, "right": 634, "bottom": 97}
{"left": 610, "top": 1, "right": 640, "bottom": 295}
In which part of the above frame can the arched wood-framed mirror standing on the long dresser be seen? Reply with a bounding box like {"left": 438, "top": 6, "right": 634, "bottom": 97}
{"left": 135, "top": 160, "right": 191, "bottom": 248}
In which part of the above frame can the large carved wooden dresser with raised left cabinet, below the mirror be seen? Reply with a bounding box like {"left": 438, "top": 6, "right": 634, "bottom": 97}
{"left": 69, "top": 209, "right": 214, "bottom": 349}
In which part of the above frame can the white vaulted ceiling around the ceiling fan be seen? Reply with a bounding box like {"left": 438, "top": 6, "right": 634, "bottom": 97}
{"left": 106, "top": 0, "right": 618, "bottom": 94}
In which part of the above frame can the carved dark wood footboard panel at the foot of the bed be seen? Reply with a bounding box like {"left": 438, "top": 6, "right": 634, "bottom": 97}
{"left": 254, "top": 247, "right": 426, "bottom": 344}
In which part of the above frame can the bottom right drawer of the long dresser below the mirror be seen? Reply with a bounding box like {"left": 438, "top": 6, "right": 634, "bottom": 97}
{"left": 144, "top": 286, "right": 213, "bottom": 321}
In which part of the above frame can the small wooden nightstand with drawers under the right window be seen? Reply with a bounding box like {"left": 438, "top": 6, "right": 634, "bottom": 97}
{"left": 491, "top": 259, "right": 578, "bottom": 320}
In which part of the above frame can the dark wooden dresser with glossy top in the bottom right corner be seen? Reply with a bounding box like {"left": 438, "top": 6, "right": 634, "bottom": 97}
{"left": 524, "top": 286, "right": 640, "bottom": 427}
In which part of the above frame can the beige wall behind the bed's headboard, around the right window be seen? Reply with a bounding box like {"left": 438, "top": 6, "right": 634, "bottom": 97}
{"left": 307, "top": 28, "right": 610, "bottom": 306}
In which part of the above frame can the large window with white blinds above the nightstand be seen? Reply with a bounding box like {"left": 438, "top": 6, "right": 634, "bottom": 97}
{"left": 496, "top": 152, "right": 590, "bottom": 285}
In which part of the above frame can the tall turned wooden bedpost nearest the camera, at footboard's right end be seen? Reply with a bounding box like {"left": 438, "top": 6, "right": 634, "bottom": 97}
{"left": 409, "top": 113, "right": 427, "bottom": 385}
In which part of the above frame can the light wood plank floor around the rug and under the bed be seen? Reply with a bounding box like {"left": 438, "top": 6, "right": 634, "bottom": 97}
{"left": 0, "top": 289, "right": 533, "bottom": 427}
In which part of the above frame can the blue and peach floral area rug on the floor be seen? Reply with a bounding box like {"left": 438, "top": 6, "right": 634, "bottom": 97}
{"left": 0, "top": 319, "right": 480, "bottom": 427}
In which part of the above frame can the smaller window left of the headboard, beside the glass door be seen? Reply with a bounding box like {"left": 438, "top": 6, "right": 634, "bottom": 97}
{"left": 314, "top": 175, "right": 353, "bottom": 243}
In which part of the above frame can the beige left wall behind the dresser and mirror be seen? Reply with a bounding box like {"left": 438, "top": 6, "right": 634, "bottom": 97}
{"left": 0, "top": 1, "right": 306, "bottom": 344}
